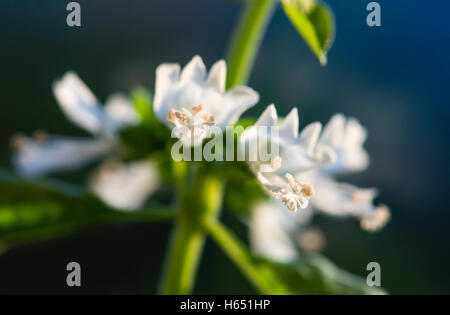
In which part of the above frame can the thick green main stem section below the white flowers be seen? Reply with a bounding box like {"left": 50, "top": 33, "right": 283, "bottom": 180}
{"left": 160, "top": 164, "right": 223, "bottom": 294}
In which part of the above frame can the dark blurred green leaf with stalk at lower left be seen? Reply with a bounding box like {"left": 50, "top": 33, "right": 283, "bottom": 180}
{"left": 0, "top": 175, "right": 173, "bottom": 251}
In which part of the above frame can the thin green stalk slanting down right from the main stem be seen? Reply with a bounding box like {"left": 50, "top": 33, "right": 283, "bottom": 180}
{"left": 206, "top": 220, "right": 274, "bottom": 294}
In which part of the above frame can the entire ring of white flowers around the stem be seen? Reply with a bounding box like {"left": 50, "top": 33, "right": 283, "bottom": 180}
{"left": 13, "top": 56, "right": 389, "bottom": 259}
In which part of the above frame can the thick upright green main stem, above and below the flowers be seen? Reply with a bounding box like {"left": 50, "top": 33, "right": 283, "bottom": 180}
{"left": 160, "top": 0, "right": 277, "bottom": 294}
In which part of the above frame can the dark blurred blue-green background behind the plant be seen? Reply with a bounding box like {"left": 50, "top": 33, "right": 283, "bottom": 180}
{"left": 0, "top": 0, "right": 450, "bottom": 294}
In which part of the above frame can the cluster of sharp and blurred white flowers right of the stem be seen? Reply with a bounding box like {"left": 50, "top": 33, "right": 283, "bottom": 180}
{"left": 248, "top": 110, "right": 390, "bottom": 261}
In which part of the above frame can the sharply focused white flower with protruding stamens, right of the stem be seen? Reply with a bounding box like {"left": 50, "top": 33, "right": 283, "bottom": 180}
{"left": 239, "top": 104, "right": 325, "bottom": 211}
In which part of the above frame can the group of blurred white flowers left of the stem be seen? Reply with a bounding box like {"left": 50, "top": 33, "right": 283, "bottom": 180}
{"left": 12, "top": 72, "right": 158, "bottom": 211}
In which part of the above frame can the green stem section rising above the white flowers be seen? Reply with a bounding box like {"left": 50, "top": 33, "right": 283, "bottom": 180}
{"left": 227, "top": 0, "right": 278, "bottom": 88}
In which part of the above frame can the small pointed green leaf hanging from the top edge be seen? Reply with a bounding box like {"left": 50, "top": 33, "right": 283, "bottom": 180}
{"left": 282, "top": 0, "right": 335, "bottom": 65}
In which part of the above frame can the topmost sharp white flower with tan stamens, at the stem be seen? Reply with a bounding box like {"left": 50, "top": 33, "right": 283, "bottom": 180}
{"left": 153, "top": 56, "right": 259, "bottom": 146}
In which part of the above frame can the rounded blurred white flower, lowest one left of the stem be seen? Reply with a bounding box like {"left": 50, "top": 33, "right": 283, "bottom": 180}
{"left": 89, "top": 160, "right": 159, "bottom": 211}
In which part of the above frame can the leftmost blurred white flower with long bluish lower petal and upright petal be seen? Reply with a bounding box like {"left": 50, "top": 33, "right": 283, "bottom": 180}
{"left": 13, "top": 72, "right": 137, "bottom": 177}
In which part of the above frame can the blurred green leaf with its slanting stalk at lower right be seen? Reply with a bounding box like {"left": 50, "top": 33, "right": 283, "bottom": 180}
{"left": 206, "top": 221, "right": 385, "bottom": 294}
